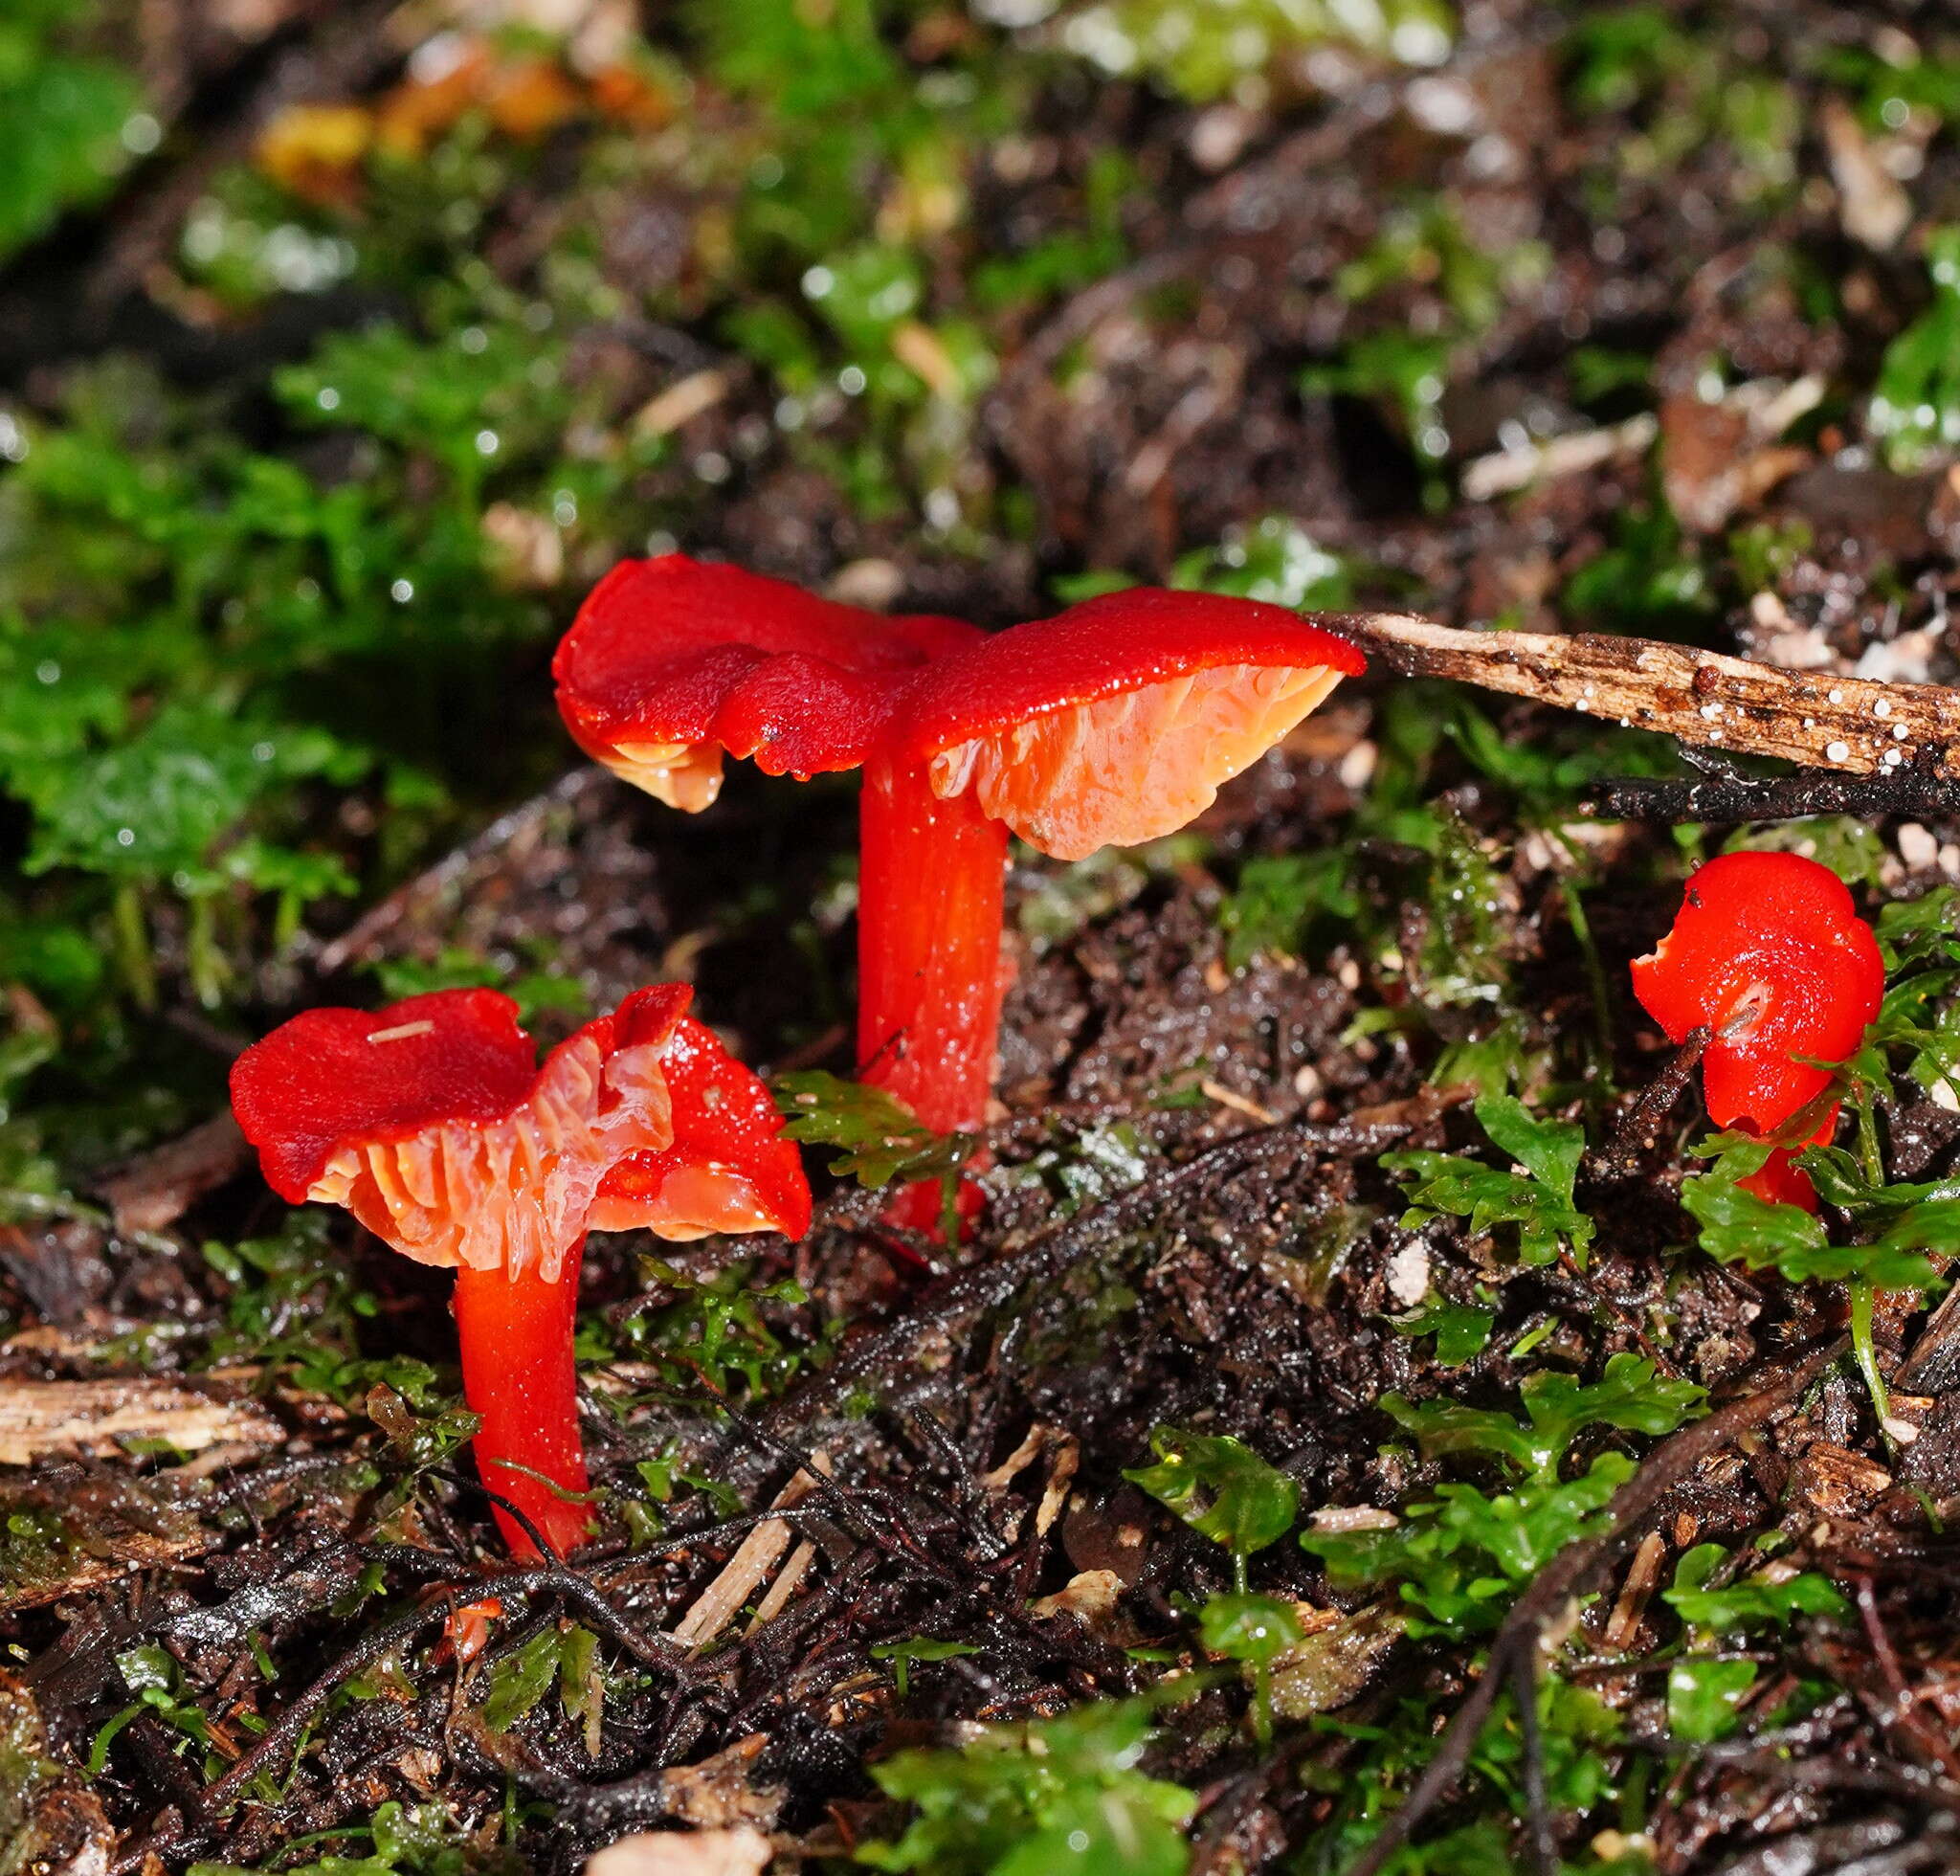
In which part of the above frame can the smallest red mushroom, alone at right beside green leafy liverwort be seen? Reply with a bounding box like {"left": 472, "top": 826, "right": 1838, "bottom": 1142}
{"left": 1633, "top": 853, "right": 1885, "bottom": 1212}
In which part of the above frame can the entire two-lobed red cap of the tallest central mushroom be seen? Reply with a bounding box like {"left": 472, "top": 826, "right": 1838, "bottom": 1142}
{"left": 553, "top": 555, "right": 1364, "bottom": 859}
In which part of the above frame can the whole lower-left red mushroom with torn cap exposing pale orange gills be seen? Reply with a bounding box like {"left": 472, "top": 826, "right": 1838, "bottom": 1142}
{"left": 232, "top": 984, "right": 810, "bottom": 1556}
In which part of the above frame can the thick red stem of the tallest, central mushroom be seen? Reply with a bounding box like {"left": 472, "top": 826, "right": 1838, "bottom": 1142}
{"left": 858, "top": 763, "right": 1008, "bottom": 1133}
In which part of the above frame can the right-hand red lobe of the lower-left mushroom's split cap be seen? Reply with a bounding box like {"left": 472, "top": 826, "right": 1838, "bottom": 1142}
{"left": 590, "top": 1016, "right": 810, "bottom": 1239}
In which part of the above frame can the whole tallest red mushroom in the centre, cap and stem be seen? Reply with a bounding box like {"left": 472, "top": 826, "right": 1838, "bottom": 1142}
{"left": 553, "top": 555, "right": 1362, "bottom": 1131}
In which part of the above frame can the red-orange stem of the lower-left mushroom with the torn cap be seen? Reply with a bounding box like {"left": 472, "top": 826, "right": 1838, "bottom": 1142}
{"left": 457, "top": 1239, "right": 590, "bottom": 1560}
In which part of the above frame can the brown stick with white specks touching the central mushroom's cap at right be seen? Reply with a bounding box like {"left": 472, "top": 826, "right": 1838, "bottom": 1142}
{"left": 1340, "top": 612, "right": 1960, "bottom": 780}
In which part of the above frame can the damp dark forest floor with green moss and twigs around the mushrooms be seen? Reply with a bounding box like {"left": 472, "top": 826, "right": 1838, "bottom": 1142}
{"left": 0, "top": 0, "right": 1960, "bottom": 1876}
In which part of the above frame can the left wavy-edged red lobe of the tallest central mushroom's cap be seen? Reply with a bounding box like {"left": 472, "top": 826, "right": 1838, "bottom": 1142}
{"left": 550, "top": 553, "right": 982, "bottom": 812}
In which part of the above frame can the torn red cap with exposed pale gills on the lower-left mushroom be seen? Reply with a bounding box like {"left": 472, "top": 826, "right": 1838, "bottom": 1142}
{"left": 232, "top": 984, "right": 808, "bottom": 1282}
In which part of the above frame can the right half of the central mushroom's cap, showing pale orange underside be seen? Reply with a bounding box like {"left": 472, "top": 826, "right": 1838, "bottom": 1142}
{"left": 894, "top": 588, "right": 1366, "bottom": 860}
